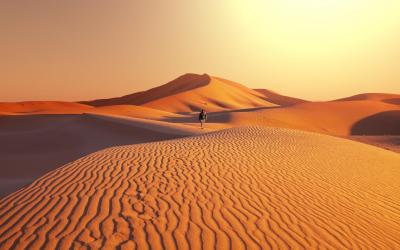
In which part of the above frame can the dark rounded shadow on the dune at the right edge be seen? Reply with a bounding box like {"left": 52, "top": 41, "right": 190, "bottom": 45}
{"left": 351, "top": 110, "right": 400, "bottom": 135}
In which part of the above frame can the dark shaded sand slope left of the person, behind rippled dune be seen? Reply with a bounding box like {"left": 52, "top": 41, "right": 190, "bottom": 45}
{"left": 0, "top": 114, "right": 203, "bottom": 197}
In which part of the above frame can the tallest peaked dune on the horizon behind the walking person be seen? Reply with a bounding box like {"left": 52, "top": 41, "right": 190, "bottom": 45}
{"left": 83, "top": 74, "right": 274, "bottom": 112}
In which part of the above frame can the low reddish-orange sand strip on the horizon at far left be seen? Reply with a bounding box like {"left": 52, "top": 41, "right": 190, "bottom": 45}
{"left": 0, "top": 101, "right": 93, "bottom": 115}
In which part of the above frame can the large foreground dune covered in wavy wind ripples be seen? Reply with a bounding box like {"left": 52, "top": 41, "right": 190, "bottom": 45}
{"left": 0, "top": 127, "right": 400, "bottom": 249}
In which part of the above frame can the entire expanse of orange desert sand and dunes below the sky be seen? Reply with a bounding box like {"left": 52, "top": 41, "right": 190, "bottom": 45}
{"left": 0, "top": 74, "right": 400, "bottom": 249}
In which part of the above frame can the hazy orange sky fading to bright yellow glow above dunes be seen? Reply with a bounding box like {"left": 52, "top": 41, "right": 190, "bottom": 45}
{"left": 0, "top": 0, "right": 400, "bottom": 101}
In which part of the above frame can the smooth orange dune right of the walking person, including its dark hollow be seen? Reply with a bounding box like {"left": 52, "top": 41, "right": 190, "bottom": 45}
{"left": 216, "top": 100, "right": 400, "bottom": 135}
